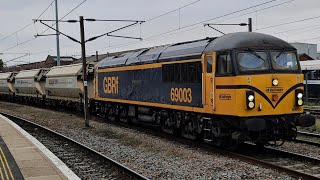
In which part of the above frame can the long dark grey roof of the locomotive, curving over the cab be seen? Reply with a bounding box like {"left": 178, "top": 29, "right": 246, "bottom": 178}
{"left": 96, "top": 32, "right": 295, "bottom": 68}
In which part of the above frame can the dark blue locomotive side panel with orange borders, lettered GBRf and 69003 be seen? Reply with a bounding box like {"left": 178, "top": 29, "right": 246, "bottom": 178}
{"left": 95, "top": 59, "right": 203, "bottom": 112}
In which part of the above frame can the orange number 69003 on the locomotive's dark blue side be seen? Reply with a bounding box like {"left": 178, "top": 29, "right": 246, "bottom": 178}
{"left": 170, "top": 88, "right": 192, "bottom": 103}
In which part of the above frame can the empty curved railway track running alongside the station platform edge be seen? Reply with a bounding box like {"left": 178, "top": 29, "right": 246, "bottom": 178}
{"left": 1, "top": 113, "right": 147, "bottom": 179}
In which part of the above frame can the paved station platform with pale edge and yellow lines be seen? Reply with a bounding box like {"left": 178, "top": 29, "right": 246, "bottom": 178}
{"left": 0, "top": 114, "right": 80, "bottom": 180}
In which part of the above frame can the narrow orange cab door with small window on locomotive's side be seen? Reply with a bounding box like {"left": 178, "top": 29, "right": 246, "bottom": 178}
{"left": 203, "top": 53, "right": 216, "bottom": 112}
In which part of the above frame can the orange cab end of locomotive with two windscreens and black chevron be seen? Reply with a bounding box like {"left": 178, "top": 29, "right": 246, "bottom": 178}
{"left": 202, "top": 33, "right": 315, "bottom": 143}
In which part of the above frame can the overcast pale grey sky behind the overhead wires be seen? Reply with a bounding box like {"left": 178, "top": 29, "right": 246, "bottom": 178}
{"left": 0, "top": 0, "right": 320, "bottom": 65}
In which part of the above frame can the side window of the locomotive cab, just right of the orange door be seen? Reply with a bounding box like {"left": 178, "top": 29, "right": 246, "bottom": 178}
{"left": 216, "top": 53, "right": 232, "bottom": 75}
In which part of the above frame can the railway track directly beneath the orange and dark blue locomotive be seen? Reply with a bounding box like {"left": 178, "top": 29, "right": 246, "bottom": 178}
{"left": 95, "top": 116, "right": 320, "bottom": 179}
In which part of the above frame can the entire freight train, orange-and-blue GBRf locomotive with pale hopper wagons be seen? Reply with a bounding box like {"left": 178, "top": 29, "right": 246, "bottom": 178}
{"left": 0, "top": 32, "right": 315, "bottom": 147}
